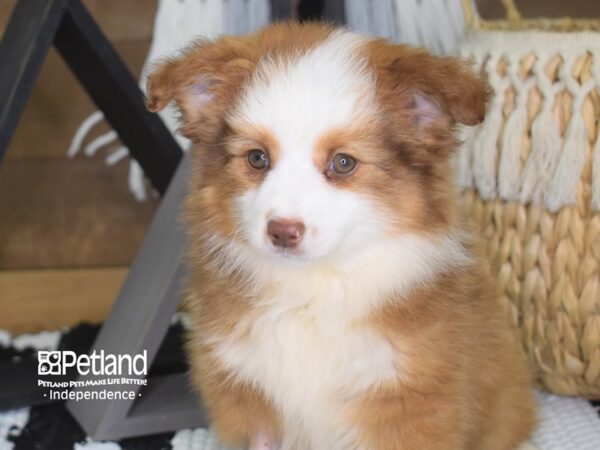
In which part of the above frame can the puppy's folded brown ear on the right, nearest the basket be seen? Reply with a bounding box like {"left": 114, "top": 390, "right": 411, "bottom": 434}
{"left": 387, "top": 46, "right": 489, "bottom": 126}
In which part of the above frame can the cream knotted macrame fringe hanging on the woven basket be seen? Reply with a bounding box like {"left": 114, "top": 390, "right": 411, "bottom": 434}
{"left": 458, "top": 32, "right": 600, "bottom": 211}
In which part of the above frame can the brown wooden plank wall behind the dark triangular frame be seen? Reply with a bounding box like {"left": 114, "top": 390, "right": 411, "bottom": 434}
{"left": 0, "top": 0, "right": 158, "bottom": 333}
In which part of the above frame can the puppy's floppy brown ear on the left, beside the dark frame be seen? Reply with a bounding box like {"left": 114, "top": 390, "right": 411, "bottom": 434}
{"left": 146, "top": 37, "right": 256, "bottom": 135}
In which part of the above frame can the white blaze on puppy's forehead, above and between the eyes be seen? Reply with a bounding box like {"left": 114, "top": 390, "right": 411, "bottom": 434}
{"left": 230, "top": 30, "right": 376, "bottom": 153}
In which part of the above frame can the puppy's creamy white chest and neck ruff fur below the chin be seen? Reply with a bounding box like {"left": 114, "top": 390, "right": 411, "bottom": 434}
{"left": 198, "top": 235, "right": 470, "bottom": 450}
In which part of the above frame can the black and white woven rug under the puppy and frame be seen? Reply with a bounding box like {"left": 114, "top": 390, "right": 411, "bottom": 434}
{"left": 0, "top": 322, "right": 600, "bottom": 450}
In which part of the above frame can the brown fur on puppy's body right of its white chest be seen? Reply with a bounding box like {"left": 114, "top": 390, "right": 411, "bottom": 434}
{"left": 349, "top": 255, "right": 535, "bottom": 450}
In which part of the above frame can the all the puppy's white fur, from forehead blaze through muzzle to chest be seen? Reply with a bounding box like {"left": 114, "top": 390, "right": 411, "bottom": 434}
{"left": 198, "top": 32, "right": 469, "bottom": 450}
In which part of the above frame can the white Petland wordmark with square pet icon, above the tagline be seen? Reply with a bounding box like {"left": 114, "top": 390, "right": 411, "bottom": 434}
{"left": 38, "top": 350, "right": 148, "bottom": 377}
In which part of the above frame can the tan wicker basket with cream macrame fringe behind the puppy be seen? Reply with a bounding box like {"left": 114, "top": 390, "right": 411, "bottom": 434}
{"left": 456, "top": 0, "right": 600, "bottom": 398}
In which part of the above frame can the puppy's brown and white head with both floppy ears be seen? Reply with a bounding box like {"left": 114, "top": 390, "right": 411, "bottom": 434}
{"left": 147, "top": 24, "right": 486, "bottom": 264}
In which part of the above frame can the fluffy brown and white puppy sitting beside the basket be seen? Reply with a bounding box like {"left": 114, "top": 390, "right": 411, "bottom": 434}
{"left": 147, "top": 23, "right": 534, "bottom": 450}
